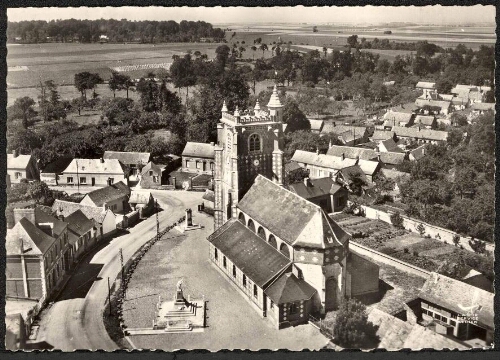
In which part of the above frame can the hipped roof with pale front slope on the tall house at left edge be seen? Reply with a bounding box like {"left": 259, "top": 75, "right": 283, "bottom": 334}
{"left": 5, "top": 217, "right": 56, "bottom": 255}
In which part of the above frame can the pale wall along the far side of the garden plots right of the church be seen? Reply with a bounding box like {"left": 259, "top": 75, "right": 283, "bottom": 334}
{"left": 354, "top": 205, "right": 495, "bottom": 252}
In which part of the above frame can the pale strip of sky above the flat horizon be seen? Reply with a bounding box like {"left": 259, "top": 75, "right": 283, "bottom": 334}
{"left": 7, "top": 5, "right": 495, "bottom": 25}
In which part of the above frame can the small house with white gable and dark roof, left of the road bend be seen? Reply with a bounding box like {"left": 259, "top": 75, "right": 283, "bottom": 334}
{"left": 80, "top": 181, "right": 130, "bottom": 214}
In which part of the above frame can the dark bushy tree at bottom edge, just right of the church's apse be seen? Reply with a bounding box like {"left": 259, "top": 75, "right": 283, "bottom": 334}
{"left": 333, "top": 298, "right": 378, "bottom": 348}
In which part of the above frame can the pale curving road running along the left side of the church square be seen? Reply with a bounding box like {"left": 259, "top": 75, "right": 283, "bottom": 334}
{"left": 37, "top": 191, "right": 203, "bottom": 351}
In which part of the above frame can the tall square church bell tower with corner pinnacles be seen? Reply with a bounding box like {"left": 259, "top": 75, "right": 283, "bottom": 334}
{"left": 214, "top": 86, "right": 284, "bottom": 229}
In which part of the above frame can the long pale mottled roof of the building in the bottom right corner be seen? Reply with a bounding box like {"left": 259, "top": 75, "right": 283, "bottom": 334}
{"left": 419, "top": 272, "right": 495, "bottom": 329}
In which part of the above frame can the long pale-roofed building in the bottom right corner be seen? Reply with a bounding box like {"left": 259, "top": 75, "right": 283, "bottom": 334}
{"left": 415, "top": 272, "right": 495, "bottom": 346}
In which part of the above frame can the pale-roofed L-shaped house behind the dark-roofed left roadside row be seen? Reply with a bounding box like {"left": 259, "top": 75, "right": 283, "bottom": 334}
{"left": 52, "top": 199, "right": 116, "bottom": 241}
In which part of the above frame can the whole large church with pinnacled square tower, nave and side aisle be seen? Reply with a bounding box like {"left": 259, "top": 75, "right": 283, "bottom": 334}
{"left": 208, "top": 87, "right": 379, "bottom": 329}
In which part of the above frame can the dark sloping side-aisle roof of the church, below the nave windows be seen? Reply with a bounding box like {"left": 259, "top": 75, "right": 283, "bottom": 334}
{"left": 208, "top": 219, "right": 292, "bottom": 288}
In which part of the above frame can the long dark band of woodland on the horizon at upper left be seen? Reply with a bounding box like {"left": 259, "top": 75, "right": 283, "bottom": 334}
{"left": 7, "top": 19, "right": 225, "bottom": 43}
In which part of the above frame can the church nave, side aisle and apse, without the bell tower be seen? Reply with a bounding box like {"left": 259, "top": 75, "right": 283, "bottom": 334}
{"left": 208, "top": 175, "right": 378, "bottom": 328}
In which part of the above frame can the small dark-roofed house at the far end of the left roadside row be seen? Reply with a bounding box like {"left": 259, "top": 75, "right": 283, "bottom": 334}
{"left": 63, "top": 210, "right": 97, "bottom": 261}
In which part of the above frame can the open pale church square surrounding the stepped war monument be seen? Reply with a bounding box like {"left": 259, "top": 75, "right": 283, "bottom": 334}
{"left": 123, "top": 212, "right": 328, "bottom": 351}
